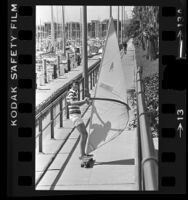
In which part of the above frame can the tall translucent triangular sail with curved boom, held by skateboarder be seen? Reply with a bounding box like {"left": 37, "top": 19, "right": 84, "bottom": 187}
{"left": 86, "top": 18, "right": 129, "bottom": 153}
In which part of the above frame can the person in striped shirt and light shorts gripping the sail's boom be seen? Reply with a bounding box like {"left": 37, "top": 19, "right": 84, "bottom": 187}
{"left": 66, "top": 80, "right": 92, "bottom": 159}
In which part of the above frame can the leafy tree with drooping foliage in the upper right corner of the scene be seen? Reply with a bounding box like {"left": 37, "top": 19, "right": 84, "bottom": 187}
{"left": 126, "top": 6, "right": 159, "bottom": 60}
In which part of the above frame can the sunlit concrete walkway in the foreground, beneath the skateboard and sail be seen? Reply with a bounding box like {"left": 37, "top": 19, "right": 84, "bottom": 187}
{"left": 36, "top": 126, "right": 139, "bottom": 191}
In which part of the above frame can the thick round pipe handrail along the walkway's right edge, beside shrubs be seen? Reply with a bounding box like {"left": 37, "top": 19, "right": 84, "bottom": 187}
{"left": 136, "top": 67, "right": 158, "bottom": 190}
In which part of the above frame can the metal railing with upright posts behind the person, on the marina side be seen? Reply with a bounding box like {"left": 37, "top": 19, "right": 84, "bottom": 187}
{"left": 35, "top": 60, "right": 100, "bottom": 153}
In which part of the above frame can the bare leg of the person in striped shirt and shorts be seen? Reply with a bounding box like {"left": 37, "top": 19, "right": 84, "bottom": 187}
{"left": 76, "top": 124, "right": 88, "bottom": 156}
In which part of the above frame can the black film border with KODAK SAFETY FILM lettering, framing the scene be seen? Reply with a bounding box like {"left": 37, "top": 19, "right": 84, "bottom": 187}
{"left": 8, "top": 0, "right": 186, "bottom": 196}
